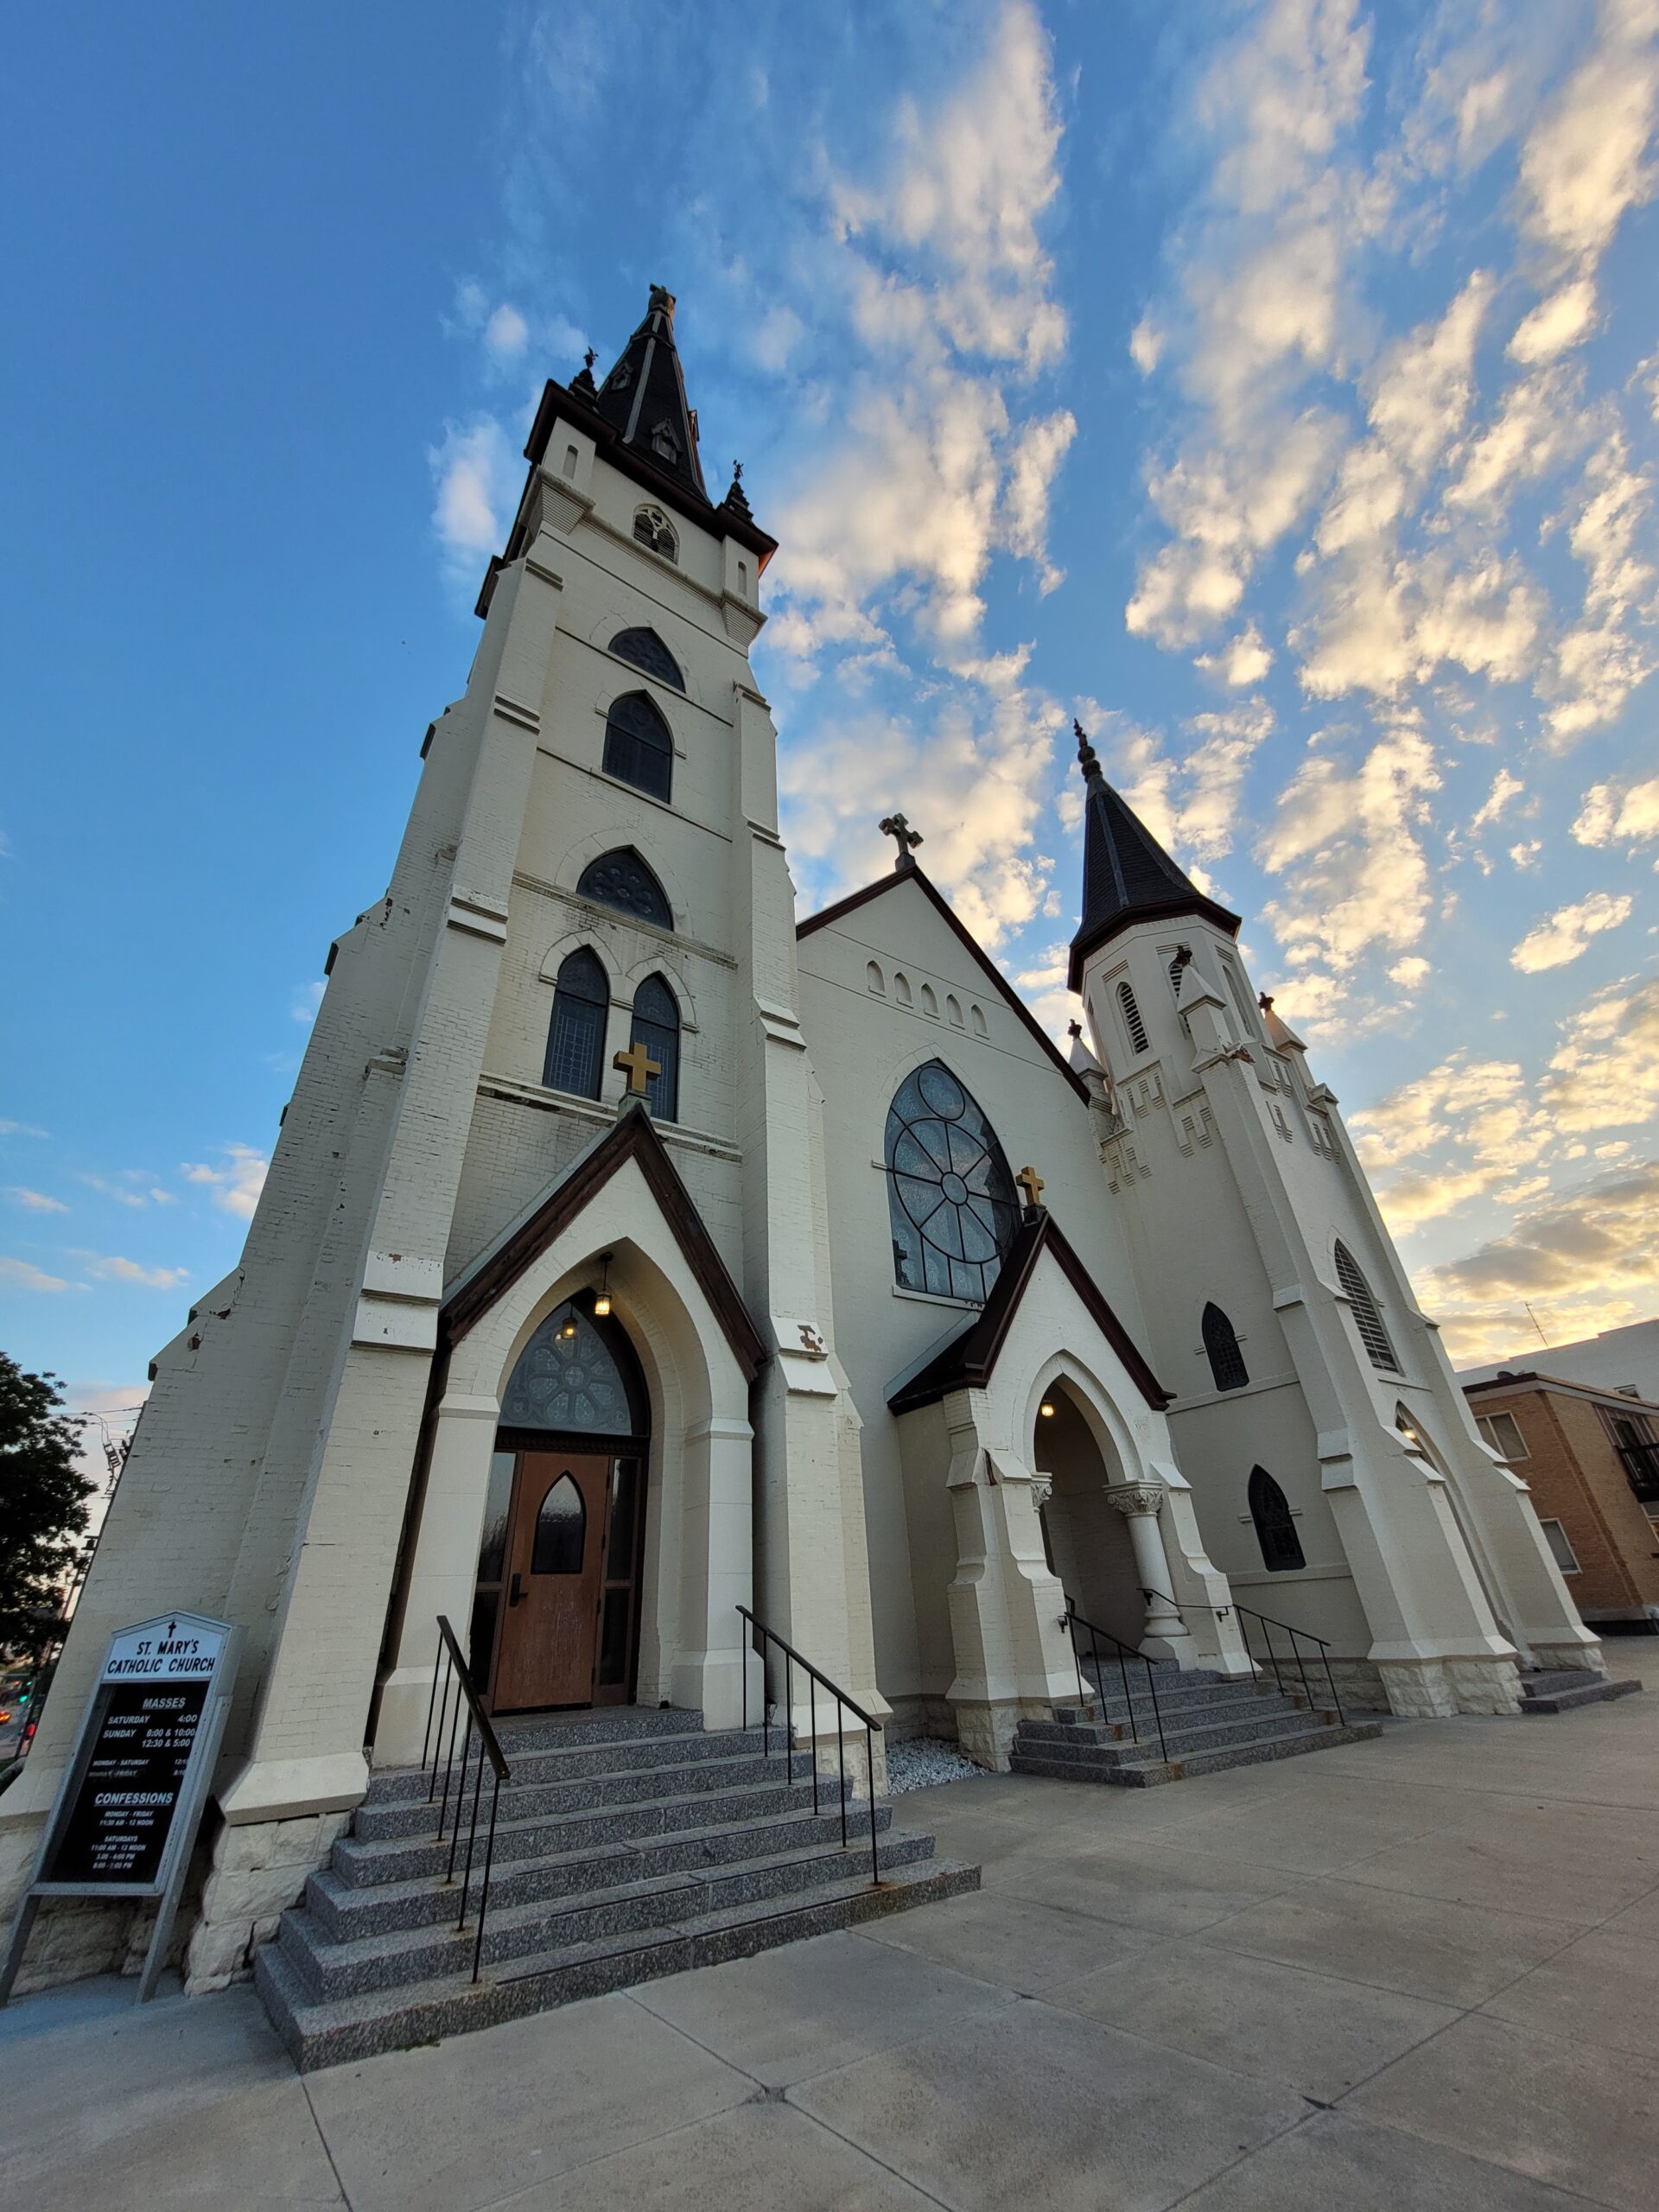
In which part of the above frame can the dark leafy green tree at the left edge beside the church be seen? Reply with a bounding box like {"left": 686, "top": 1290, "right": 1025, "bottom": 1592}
{"left": 0, "top": 1351, "right": 93, "bottom": 1646}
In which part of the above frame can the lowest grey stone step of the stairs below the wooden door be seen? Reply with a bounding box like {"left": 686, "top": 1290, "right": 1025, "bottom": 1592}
{"left": 254, "top": 1858, "right": 980, "bottom": 2073}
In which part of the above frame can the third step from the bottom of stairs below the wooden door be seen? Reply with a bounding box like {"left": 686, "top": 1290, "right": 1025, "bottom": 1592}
{"left": 305, "top": 1787, "right": 893, "bottom": 1942}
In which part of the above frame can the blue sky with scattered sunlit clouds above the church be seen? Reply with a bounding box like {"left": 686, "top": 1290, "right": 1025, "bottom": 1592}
{"left": 0, "top": 0, "right": 1659, "bottom": 1442}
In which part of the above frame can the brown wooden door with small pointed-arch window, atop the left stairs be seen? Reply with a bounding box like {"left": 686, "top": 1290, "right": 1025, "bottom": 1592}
{"left": 493, "top": 1451, "right": 611, "bottom": 1712}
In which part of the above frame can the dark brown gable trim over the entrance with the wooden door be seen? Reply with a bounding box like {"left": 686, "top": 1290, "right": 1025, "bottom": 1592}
{"left": 438, "top": 1106, "right": 770, "bottom": 1382}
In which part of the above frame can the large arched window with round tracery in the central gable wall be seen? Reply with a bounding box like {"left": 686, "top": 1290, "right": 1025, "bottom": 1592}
{"left": 887, "top": 1059, "right": 1020, "bottom": 1305}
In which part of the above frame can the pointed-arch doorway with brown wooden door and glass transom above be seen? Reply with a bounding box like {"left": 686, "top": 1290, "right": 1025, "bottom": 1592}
{"left": 469, "top": 1292, "right": 651, "bottom": 1712}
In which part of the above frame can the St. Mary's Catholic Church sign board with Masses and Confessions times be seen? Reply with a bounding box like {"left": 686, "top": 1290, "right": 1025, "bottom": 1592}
{"left": 0, "top": 1612, "right": 241, "bottom": 2004}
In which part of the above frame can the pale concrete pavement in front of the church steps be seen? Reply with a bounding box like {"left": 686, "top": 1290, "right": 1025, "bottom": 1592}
{"left": 0, "top": 1639, "right": 1659, "bottom": 2212}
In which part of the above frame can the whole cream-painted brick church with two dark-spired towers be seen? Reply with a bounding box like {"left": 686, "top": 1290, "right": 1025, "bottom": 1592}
{"left": 0, "top": 289, "right": 1599, "bottom": 1986}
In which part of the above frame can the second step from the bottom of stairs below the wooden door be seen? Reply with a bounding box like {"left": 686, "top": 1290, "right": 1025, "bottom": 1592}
{"left": 279, "top": 1834, "right": 933, "bottom": 2004}
